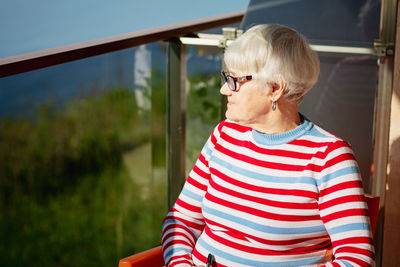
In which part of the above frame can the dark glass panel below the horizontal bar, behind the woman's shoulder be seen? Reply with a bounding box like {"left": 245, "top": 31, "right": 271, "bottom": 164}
{"left": 300, "top": 53, "right": 378, "bottom": 189}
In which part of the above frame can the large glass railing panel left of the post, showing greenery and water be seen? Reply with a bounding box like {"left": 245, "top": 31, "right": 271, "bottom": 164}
{"left": 0, "top": 42, "right": 167, "bottom": 266}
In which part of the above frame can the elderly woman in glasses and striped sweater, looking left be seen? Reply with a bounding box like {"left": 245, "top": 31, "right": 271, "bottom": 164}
{"left": 162, "top": 25, "right": 374, "bottom": 266}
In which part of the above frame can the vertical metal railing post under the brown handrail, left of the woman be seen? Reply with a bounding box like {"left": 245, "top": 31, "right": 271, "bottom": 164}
{"left": 167, "top": 38, "right": 186, "bottom": 207}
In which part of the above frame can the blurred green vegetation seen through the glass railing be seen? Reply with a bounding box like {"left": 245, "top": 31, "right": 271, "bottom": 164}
{"left": 0, "top": 71, "right": 220, "bottom": 266}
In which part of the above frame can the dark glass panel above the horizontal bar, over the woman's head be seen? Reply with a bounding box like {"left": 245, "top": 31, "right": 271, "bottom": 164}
{"left": 242, "top": 0, "right": 381, "bottom": 47}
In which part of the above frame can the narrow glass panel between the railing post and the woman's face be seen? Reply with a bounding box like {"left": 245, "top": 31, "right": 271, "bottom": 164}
{"left": 186, "top": 46, "right": 222, "bottom": 177}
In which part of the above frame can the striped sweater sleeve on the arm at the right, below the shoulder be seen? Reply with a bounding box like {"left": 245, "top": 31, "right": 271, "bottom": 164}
{"left": 318, "top": 141, "right": 375, "bottom": 266}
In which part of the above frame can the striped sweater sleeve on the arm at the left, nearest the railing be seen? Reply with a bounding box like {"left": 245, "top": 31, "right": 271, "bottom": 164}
{"left": 162, "top": 123, "right": 222, "bottom": 266}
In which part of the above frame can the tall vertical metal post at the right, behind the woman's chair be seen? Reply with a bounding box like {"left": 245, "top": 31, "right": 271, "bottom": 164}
{"left": 371, "top": 0, "right": 397, "bottom": 266}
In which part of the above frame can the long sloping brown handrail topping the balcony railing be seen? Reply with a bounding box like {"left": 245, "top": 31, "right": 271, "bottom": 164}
{"left": 0, "top": 11, "right": 244, "bottom": 78}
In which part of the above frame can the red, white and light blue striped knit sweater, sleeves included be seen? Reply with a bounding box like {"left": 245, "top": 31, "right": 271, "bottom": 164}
{"left": 162, "top": 117, "right": 374, "bottom": 267}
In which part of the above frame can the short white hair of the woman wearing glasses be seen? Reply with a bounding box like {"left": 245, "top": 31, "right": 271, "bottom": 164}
{"left": 224, "top": 24, "right": 319, "bottom": 103}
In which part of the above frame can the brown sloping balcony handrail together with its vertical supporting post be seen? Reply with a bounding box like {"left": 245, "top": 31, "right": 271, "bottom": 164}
{"left": 0, "top": 12, "right": 244, "bottom": 206}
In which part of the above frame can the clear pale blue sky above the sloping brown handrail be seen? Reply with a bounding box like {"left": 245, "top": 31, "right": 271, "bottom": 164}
{"left": 0, "top": 0, "right": 249, "bottom": 58}
